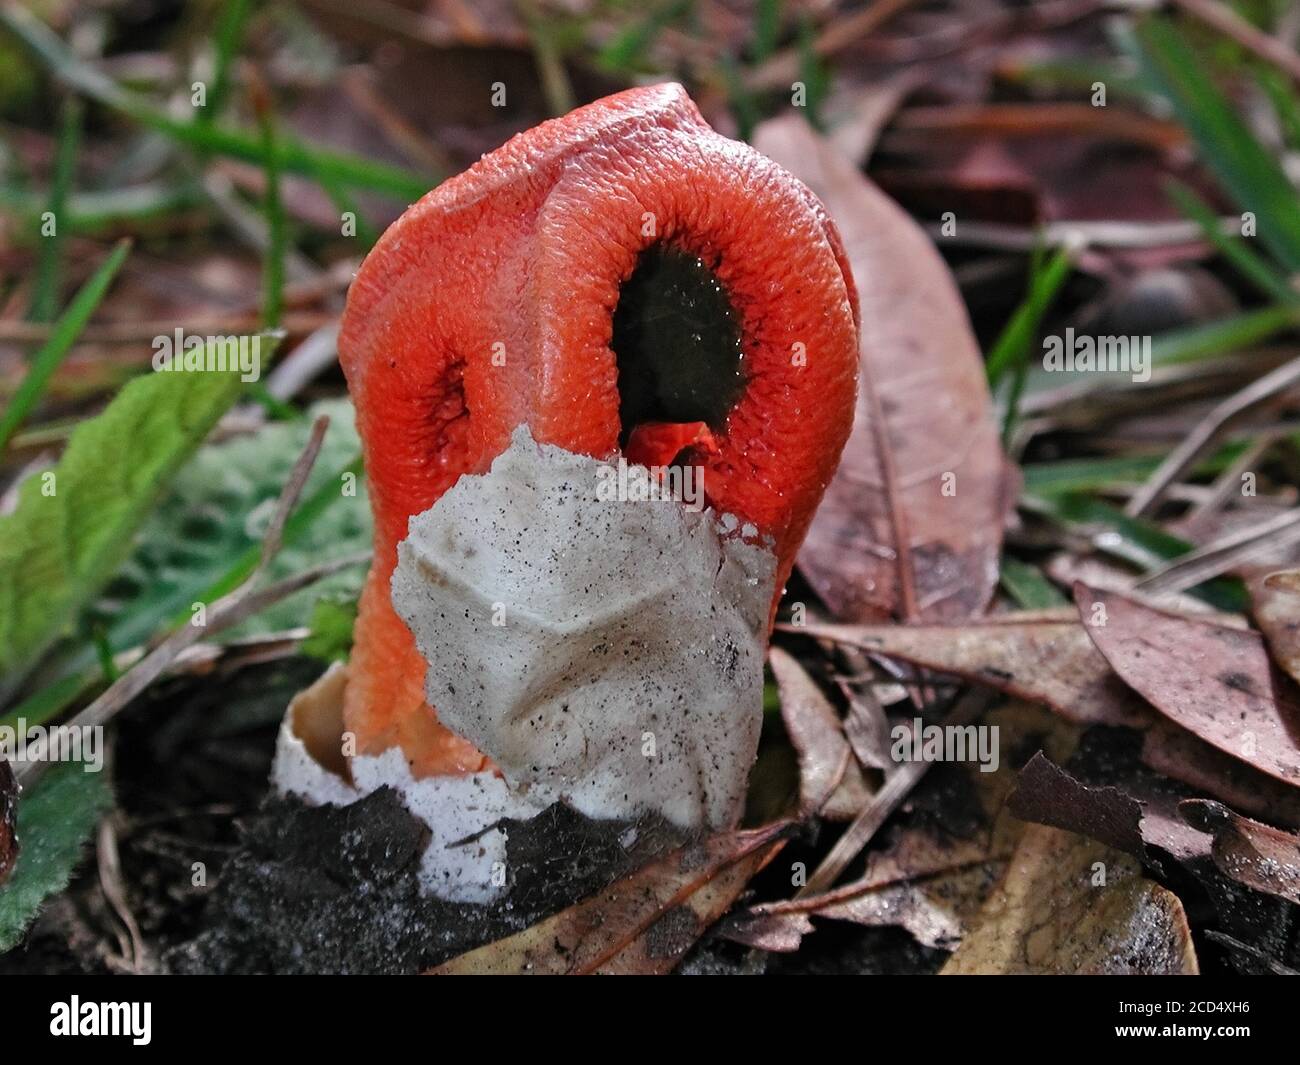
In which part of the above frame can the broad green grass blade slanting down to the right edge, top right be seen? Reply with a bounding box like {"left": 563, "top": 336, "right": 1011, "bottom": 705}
{"left": 1138, "top": 16, "right": 1300, "bottom": 273}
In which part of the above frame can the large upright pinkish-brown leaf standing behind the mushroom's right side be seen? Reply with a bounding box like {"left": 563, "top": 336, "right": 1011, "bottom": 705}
{"left": 754, "top": 114, "right": 1015, "bottom": 622}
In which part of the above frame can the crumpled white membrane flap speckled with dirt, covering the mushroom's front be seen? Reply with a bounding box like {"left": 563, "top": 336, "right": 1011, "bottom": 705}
{"left": 393, "top": 428, "right": 776, "bottom": 828}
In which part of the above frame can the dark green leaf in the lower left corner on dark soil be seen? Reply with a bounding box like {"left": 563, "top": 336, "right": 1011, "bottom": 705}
{"left": 0, "top": 762, "right": 113, "bottom": 952}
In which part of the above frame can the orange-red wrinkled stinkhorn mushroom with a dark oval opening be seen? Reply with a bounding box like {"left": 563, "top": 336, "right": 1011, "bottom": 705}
{"left": 339, "top": 85, "right": 858, "bottom": 816}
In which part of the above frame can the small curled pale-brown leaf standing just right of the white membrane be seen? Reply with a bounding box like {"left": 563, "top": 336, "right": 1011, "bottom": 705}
{"left": 767, "top": 648, "right": 870, "bottom": 821}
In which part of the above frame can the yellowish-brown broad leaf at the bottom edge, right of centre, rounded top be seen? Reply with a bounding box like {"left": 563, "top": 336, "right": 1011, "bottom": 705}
{"left": 941, "top": 824, "right": 1197, "bottom": 975}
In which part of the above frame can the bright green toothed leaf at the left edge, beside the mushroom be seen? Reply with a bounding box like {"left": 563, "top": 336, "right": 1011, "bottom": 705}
{"left": 0, "top": 345, "right": 253, "bottom": 681}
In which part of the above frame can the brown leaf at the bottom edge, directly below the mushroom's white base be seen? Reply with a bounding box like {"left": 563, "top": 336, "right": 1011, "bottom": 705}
{"left": 430, "top": 821, "right": 790, "bottom": 975}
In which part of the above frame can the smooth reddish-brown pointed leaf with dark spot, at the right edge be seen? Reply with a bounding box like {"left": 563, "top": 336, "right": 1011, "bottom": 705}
{"left": 1075, "top": 584, "right": 1300, "bottom": 784}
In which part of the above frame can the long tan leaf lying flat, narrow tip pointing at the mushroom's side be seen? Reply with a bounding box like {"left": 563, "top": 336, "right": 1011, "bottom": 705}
{"left": 789, "top": 614, "right": 1151, "bottom": 727}
